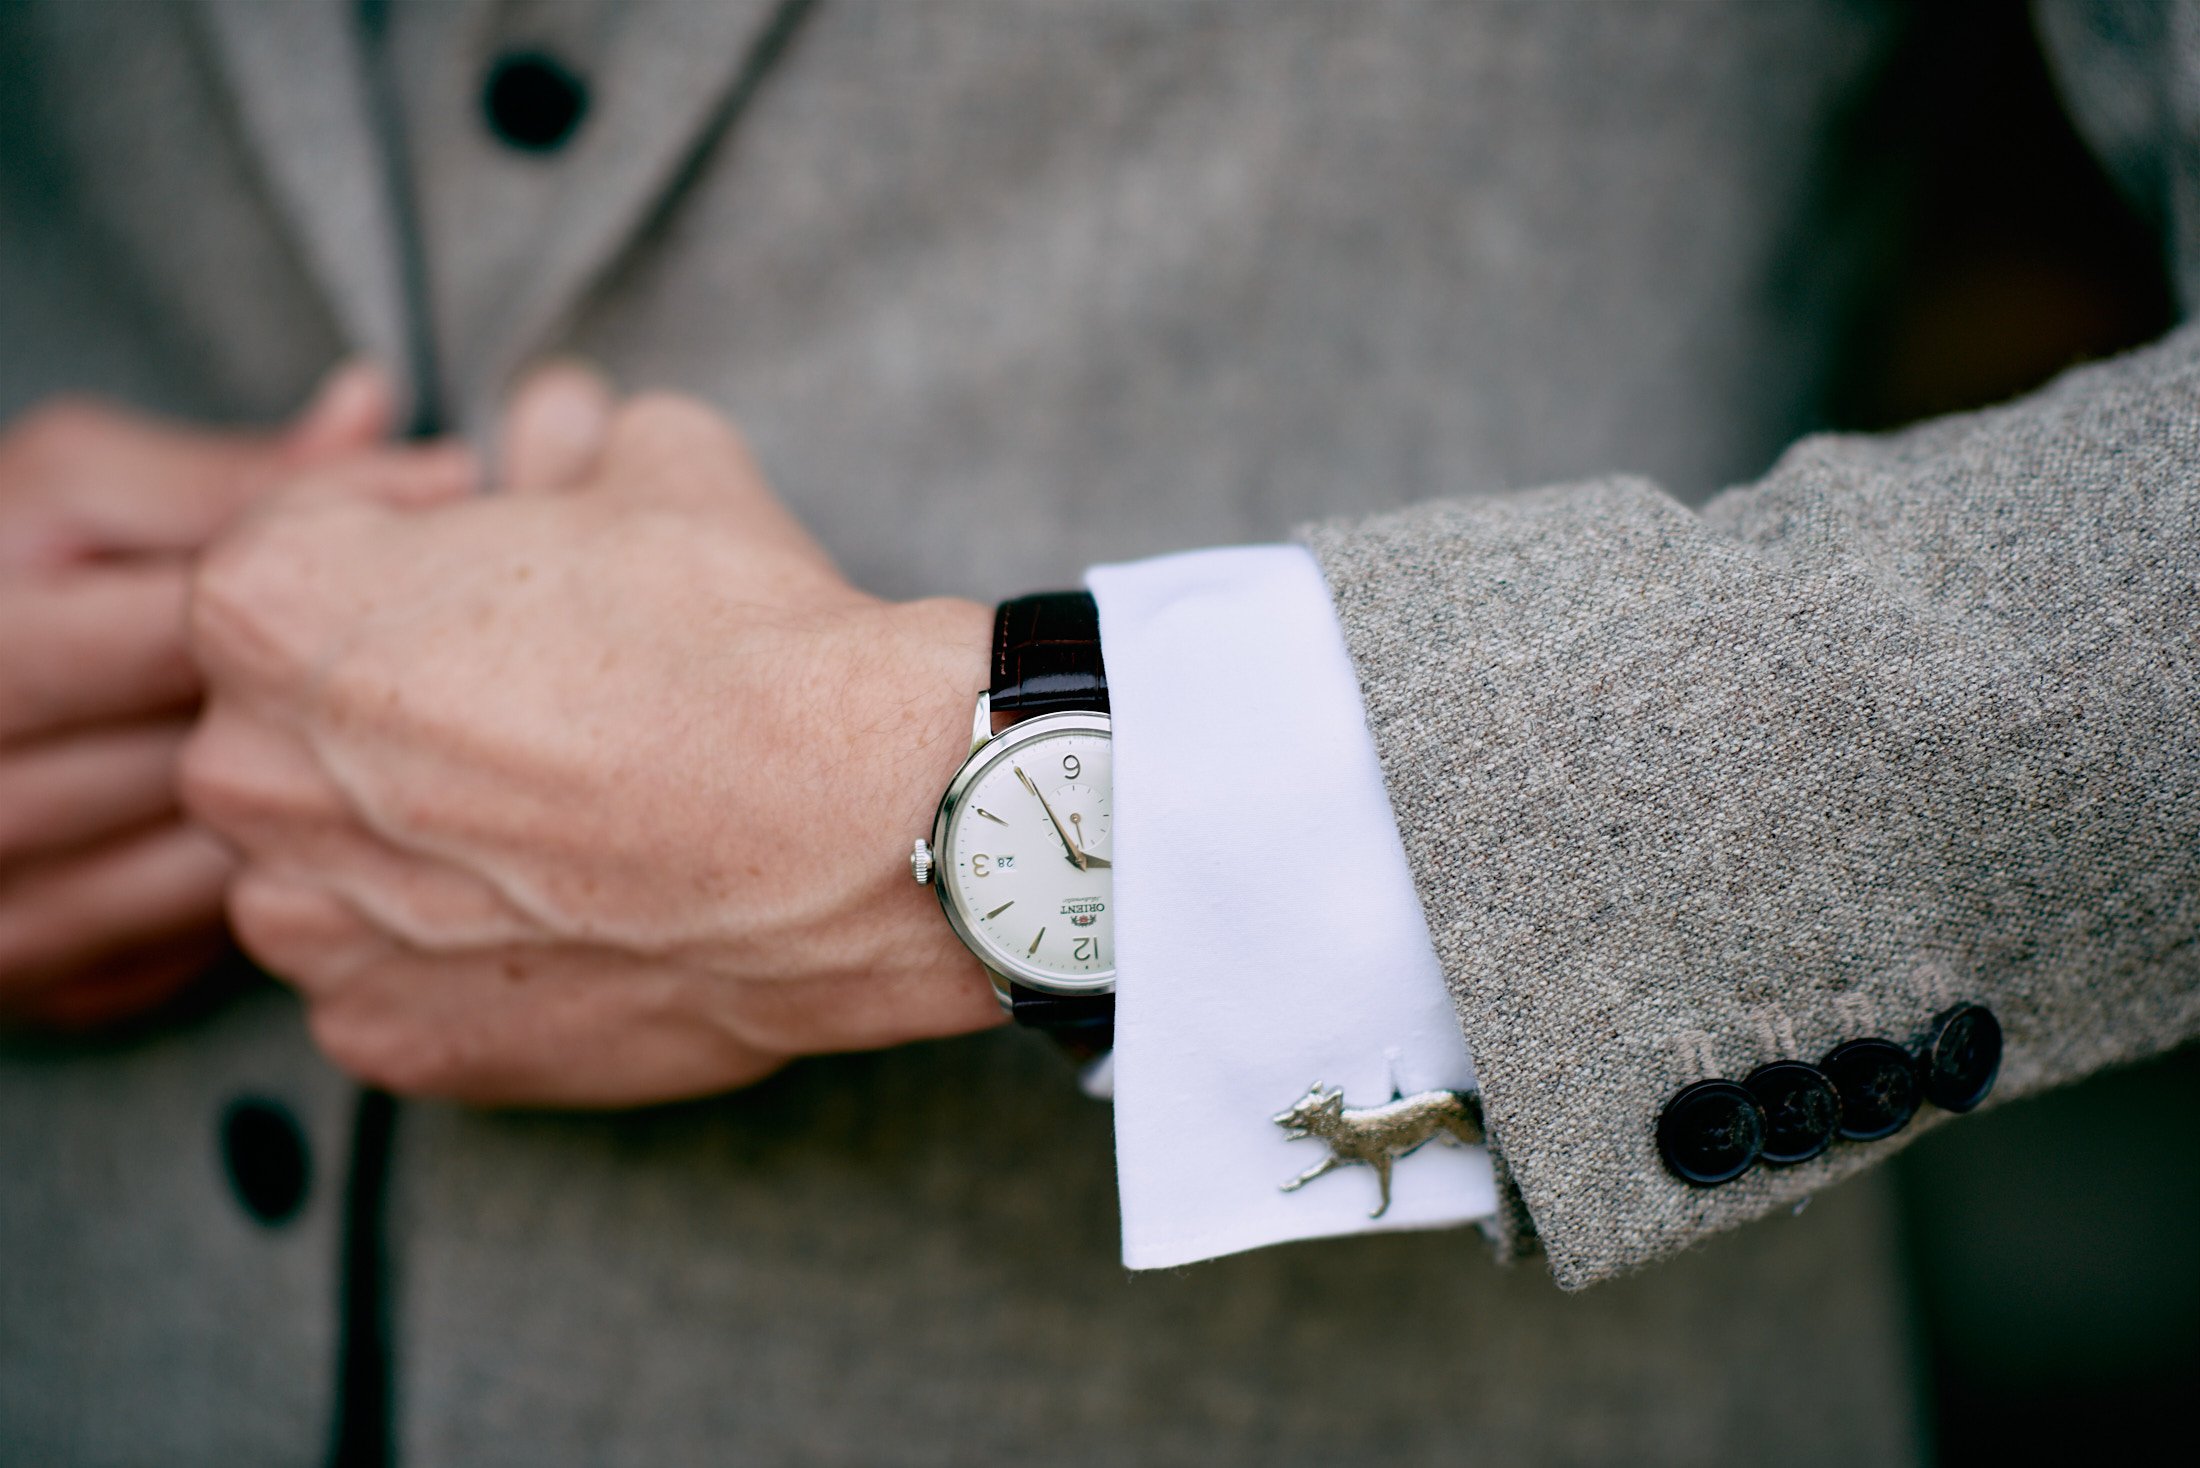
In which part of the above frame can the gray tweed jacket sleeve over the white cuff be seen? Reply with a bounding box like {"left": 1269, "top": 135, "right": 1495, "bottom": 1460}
{"left": 1309, "top": 330, "right": 2200, "bottom": 1288}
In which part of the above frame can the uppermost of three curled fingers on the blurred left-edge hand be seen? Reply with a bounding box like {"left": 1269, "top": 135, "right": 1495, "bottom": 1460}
{"left": 0, "top": 561, "right": 198, "bottom": 742}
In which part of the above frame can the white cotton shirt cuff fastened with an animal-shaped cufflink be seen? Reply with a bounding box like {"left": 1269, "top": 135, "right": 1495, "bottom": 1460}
{"left": 1087, "top": 546, "right": 1496, "bottom": 1270}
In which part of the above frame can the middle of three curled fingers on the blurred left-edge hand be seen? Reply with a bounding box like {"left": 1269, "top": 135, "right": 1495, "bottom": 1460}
{"left": 0, "top": 720, "right": 191, "bottom": 869}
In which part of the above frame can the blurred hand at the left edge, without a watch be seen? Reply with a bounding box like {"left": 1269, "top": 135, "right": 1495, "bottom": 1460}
{"left": 0, "top": 368, "right": 415, "bottom": 1028}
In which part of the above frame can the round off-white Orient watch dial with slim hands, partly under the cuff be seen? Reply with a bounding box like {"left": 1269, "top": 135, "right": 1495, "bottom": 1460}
{"left": 935, "top": 713, "right": 1115, "bottom": 993}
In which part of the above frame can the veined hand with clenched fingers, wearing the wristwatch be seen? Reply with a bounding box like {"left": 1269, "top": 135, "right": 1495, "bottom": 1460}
{"left": 185, "top": 385, "right": 999, "bottom": 1105}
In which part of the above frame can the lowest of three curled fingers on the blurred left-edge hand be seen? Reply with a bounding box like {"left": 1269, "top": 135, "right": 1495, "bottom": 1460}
{"left": 0, "top": 825, "right": 233, "bottom": 988}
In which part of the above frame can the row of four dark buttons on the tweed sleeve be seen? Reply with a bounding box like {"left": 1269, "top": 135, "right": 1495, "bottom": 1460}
{"left": 1657, "top": 1004, "right": 2002, "bottom": 1188}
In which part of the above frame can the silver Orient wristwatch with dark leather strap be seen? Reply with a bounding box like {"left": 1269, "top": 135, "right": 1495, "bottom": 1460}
{"left": 909, "top": 592, "right": 1115, "bottom": 1059}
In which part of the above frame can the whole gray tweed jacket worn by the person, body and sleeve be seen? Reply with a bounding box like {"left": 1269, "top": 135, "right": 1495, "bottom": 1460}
{"left": 0, "top": 0, "right": 2200, "bottom": 1466}
